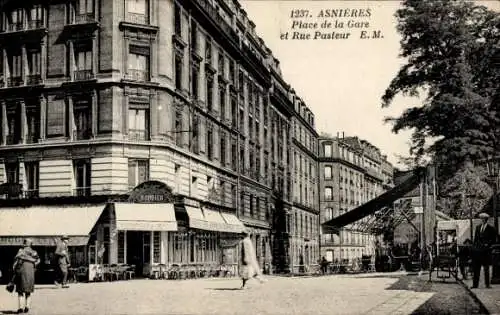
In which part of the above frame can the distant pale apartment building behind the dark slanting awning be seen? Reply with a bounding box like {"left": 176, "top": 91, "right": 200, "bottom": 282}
{"left": 319, "top": 135, "right": 393, "bottom": 261}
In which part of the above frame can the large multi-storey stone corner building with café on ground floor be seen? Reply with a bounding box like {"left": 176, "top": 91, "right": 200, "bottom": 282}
{"left": 0, "top": 0, "right": 306, "bottom": 276}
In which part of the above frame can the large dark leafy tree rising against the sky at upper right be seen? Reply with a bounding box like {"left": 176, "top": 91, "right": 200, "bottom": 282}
{"left": 382, "top": 0, "right": 500, "bottom": 176}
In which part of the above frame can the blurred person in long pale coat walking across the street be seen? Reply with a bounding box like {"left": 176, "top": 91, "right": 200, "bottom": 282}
{"left": 240, "top": 231, "right": 266, "bottom": 289}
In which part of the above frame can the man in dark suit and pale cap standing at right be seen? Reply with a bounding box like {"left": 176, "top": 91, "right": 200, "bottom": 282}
{"left": 472, "top": 213, "right": 497, "bottom": 288}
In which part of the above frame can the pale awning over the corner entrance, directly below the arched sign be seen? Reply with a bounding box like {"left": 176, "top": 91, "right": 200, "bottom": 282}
{"left": 114, "top": 203, "right": 177, "bottom": 231}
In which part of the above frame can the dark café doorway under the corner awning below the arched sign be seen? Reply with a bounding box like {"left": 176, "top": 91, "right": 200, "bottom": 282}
{"left": 127, "top": 231, "right": 151, "bottom": 277}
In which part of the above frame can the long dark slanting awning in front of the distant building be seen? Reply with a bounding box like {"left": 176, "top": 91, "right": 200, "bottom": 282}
{"left": 322, "top": 168, "right": 425, "bottom": 233}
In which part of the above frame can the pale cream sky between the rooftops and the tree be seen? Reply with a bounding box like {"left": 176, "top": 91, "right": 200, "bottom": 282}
{"left": 241, "top": 0, "right": 498, "bottom": 165}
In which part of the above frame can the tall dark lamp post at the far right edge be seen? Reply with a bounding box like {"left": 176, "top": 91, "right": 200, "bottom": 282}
{"left": 487, "top": 159, "right": 500, "bottom": 284}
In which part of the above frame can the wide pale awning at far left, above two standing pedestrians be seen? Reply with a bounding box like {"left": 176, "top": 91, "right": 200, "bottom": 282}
{"left": 0, "top": 205, "right": 104, "bottom": 246}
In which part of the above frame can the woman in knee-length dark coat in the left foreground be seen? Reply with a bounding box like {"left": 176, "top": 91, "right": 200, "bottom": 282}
{"left": 14, "top": 239, "right": 40, "bottom": 314}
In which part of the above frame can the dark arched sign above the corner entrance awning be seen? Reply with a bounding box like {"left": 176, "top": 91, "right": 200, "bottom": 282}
{"left": 129, "top": 181, "right": 174, "bottom": 203}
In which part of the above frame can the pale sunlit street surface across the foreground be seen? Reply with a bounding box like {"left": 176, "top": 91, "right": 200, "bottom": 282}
{"left": 0, "top": 273, "right": 480, "bottom": 315}
